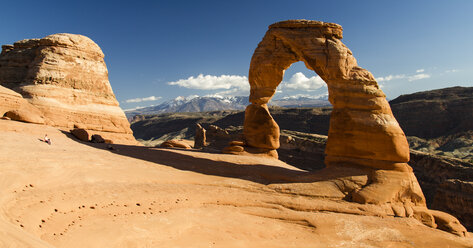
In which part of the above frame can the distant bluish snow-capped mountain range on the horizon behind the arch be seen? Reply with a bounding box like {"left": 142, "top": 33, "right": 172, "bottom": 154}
{"left": 125, "top": 95, "right": 330, "bottom": 118}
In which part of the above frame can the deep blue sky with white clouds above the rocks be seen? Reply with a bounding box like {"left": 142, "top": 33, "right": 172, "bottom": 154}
{"left": 0, "top": 0, "right": 473, "bottom": 109}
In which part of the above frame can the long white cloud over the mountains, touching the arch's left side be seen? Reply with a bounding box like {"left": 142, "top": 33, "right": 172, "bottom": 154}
{"left": 168, "top": 74, "right": 250, "bottom": 90}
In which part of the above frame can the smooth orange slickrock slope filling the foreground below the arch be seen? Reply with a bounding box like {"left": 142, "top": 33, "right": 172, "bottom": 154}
{"left": 0, "top": 120, "right": 473, "bottom": 247}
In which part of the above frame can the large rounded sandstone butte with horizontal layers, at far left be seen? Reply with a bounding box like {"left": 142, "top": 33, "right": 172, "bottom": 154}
{"left": 0, "top": 34, "right": 134, "bottom": 140}
